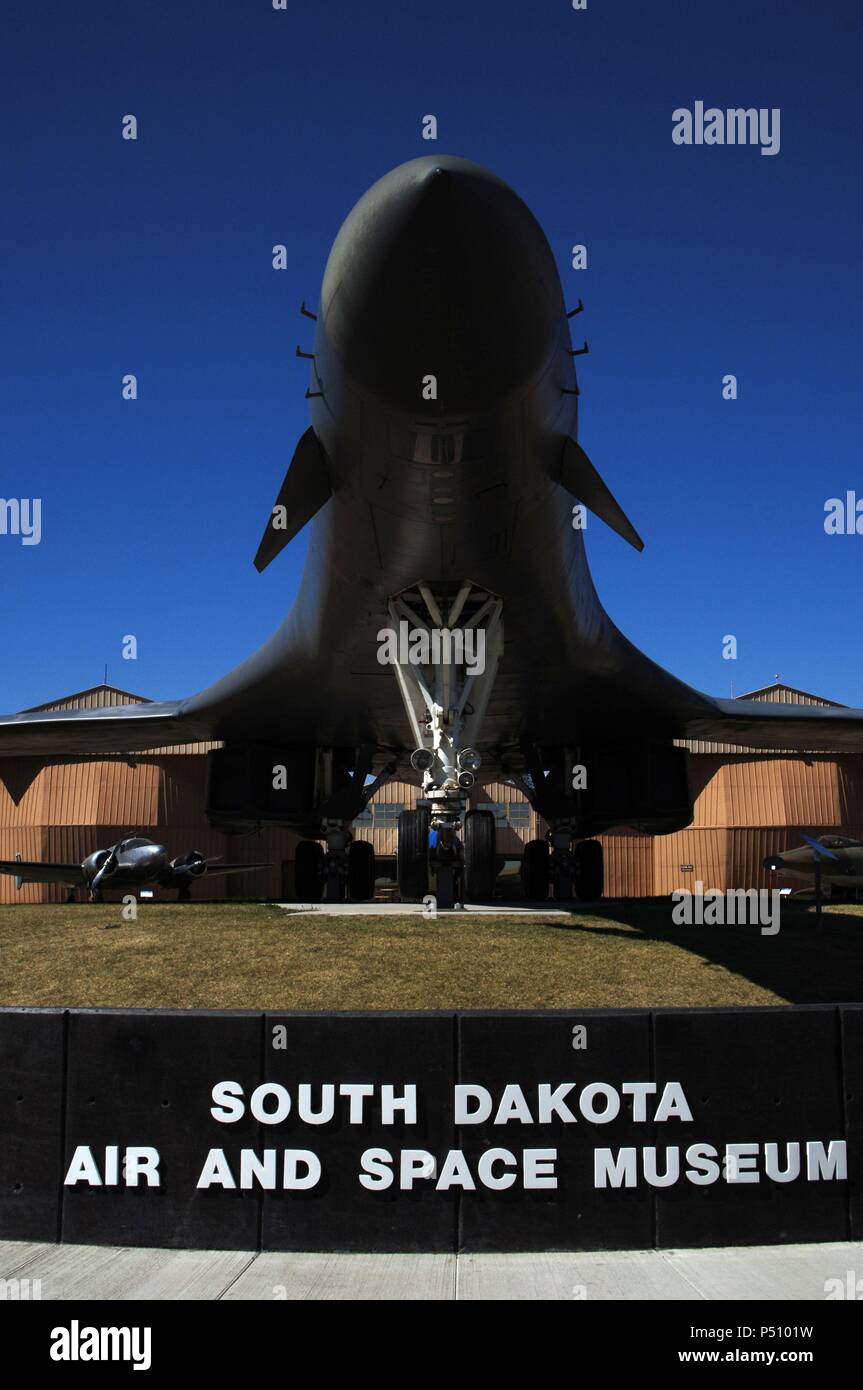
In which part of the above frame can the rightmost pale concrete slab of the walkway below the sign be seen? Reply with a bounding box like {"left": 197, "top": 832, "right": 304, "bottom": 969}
{"left": 663, "top": 1241, "right": 863, "bottom": 1302}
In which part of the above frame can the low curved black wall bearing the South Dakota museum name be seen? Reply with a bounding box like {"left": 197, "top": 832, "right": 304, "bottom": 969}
{"left": 0, "top": 1005, "right": 863, "bottom": 1251}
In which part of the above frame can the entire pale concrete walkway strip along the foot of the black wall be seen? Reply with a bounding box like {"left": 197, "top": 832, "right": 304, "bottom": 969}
{"left": 0, "top": 1241, "right": 863, "bottom": 1301}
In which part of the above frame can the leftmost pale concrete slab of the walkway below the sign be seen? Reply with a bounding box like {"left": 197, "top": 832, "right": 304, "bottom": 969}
{"left": 0, "top": 1241, "right": 254, "bottom": 1301}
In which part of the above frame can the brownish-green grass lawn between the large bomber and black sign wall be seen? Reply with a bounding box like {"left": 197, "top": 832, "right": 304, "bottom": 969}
{"left": 0, "top": 899, "right": 863, "bottom": 1009}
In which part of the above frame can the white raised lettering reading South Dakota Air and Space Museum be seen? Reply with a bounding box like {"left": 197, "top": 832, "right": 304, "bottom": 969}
{"left": 57, "top": 1080, "right": 848, "bottom": 1193}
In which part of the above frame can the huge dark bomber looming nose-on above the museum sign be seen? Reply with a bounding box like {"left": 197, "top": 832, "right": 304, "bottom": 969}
{"left": 0, "top": 154, "right": 863, "bottom": 906}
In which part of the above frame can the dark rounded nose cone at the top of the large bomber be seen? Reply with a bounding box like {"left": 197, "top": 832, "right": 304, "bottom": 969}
{"left": 322, "top": 156, "right": 563, "bottom": 416}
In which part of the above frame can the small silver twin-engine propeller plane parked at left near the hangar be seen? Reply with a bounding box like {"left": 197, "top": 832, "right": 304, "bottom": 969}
{"left": 0, "top": 835, "right": 271, "bottom": 902}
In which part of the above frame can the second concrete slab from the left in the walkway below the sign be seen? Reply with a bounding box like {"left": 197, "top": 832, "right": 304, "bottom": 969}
{"left": 224, "top": 1252, "right": 456, "bottom": 1302}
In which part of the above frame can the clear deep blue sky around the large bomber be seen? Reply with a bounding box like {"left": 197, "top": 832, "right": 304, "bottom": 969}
{"left": 0, "top": 0, "right": 863, "bottom": 712}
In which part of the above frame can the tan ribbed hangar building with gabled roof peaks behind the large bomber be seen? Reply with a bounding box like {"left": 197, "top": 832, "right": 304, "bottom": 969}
{"left": 0, "top": 682, "right": 863, "bottom": 904}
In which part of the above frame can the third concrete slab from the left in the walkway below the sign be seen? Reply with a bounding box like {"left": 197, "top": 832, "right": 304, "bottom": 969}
{"left": 456, "top": 1250, "right": 705, "bottom": 1302}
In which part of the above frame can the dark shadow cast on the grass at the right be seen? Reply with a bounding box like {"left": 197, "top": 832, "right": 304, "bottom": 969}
{"left": 528, "top": 898, "right": 863, "bottom": 1004}
